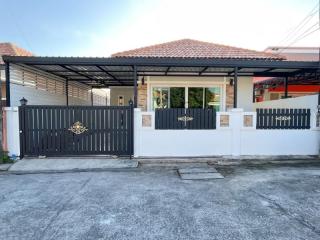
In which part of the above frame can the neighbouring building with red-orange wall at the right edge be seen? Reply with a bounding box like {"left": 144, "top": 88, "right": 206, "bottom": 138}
{"left": 254, "top": 46, "right": 320, "bottom": 102}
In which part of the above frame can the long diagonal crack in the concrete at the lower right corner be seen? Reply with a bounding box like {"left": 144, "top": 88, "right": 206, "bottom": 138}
{"left": 249, "top": 189, "right": 320, "bottom": 236}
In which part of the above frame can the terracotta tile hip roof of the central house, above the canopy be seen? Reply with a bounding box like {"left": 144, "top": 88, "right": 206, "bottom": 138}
{"left": 111, "top": 39, "right": 284, "bottom": 60}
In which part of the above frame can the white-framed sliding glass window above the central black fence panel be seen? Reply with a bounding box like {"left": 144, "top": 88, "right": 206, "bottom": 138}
{"left": 152, "top": 87, "right": 221, "bottom": 111}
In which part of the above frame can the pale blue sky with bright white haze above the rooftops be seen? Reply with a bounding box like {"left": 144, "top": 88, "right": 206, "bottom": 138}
{"left": 0, "top": 0, "right": 320, "bottom": 56}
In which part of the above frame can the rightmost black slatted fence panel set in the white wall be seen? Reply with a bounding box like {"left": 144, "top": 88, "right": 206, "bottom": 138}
{"left": 257, "top": 108, "right": 311, "bottom": 129}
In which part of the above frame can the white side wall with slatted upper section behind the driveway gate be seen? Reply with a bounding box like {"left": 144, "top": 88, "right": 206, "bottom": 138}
{"left": 10, "top": 65, "right": 108, "bottom": 106}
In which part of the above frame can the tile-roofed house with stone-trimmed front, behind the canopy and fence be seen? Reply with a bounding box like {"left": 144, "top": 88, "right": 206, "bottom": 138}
{"left": 110, "top": 39, "right": 283, "bottom": 111}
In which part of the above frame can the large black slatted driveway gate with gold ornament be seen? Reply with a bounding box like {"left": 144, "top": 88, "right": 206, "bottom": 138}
{"left": 19, "top": 105, "right": 133, "bottom": 157}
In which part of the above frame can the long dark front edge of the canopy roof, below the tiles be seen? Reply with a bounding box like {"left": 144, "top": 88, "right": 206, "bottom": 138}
{"left": 2, "top": 56, "right": 319, "bottom": 69}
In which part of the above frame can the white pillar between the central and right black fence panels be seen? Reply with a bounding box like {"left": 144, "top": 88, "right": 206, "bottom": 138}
{"left": 230, "top": 108, "right": 243, "bottom": 156}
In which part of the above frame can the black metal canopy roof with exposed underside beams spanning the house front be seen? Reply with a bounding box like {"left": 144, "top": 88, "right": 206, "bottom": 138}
{"left": 3, "top": 56, "right": 320, "bottom": 88}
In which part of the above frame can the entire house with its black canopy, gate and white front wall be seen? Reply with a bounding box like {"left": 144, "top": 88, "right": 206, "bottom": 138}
{"left": 3, "top": 39, "right": 320, "bottom": 157}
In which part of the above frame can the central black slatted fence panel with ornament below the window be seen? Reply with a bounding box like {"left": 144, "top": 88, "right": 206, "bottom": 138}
{"left": 155, "top": 108, "right": 216, "bottom": 129}
